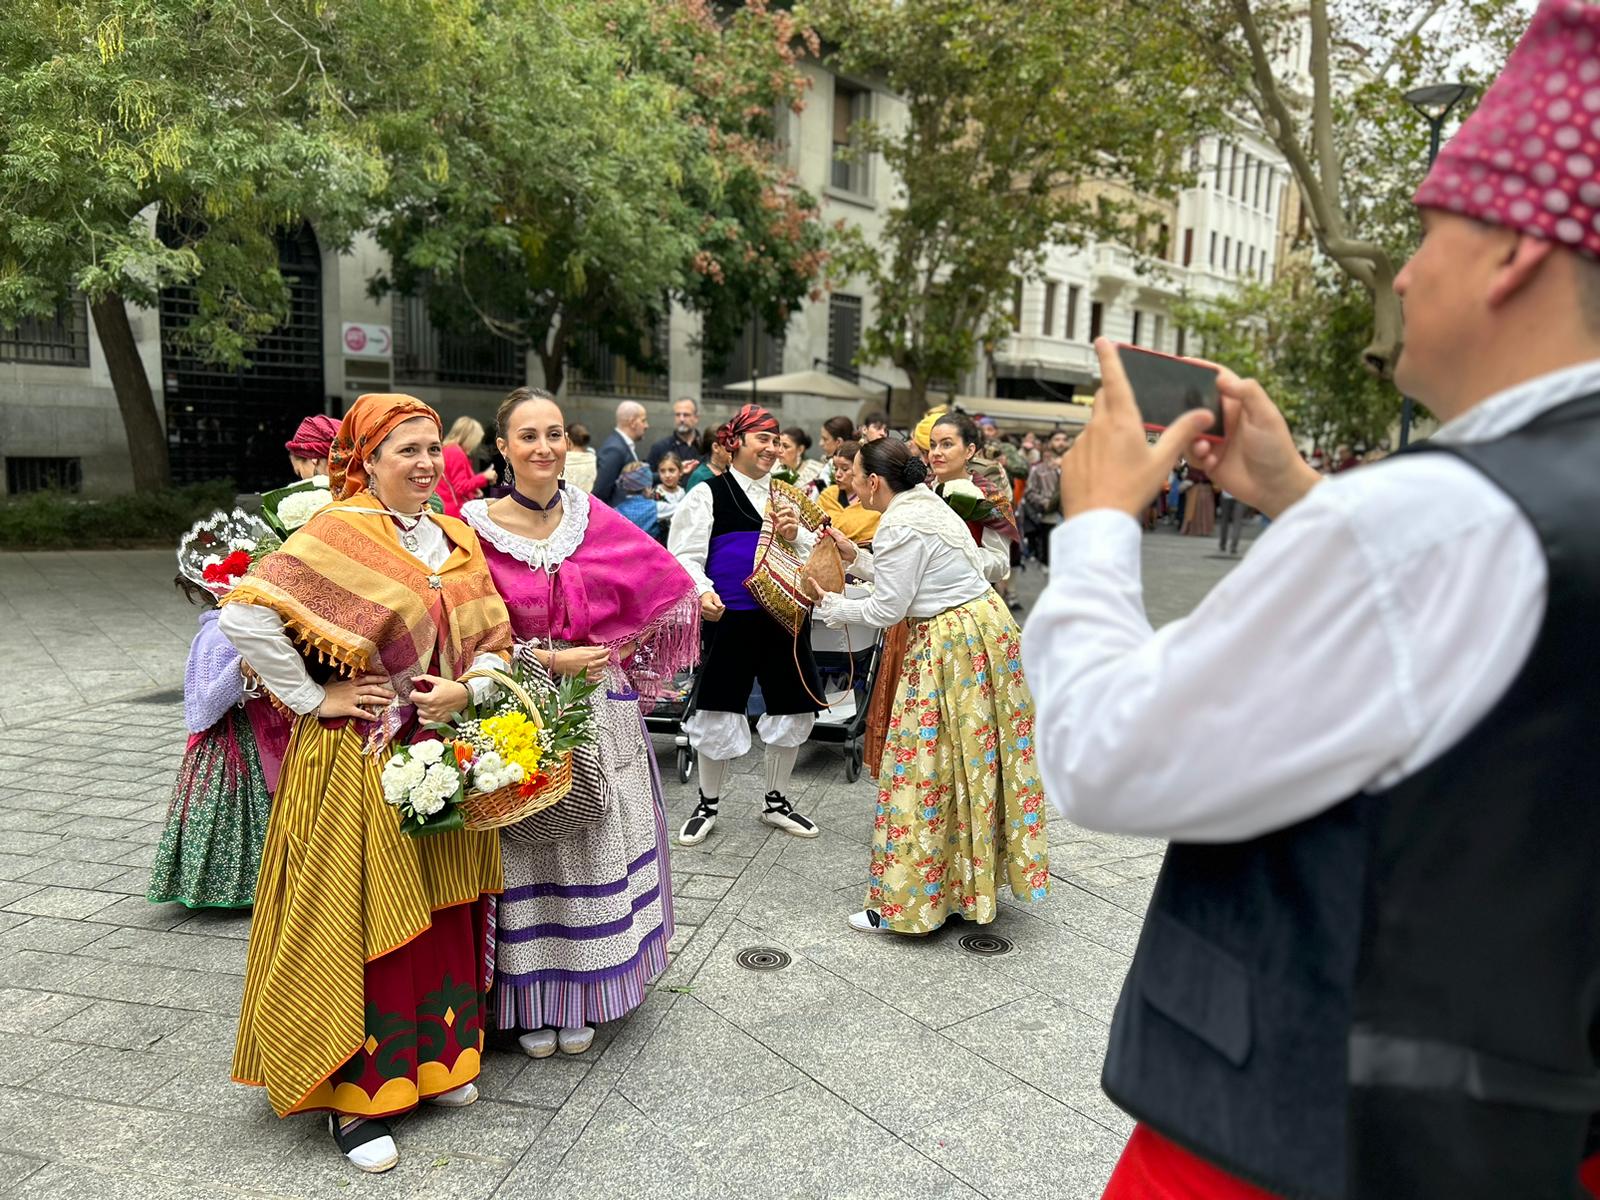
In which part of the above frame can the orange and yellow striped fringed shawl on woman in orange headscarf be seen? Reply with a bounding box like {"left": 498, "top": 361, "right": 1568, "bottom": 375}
{"left": 222, "top": 494, "right": 512, "bottom": 744}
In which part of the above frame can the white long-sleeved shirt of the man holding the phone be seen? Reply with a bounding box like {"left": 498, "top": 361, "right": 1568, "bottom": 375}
{"left": 1022, "top": 360, "right": 1600, "bottom": 842}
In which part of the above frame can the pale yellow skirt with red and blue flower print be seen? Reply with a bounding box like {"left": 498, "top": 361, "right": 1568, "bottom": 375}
{"left": 867, "top": 589, "right": 1050, "bottom": 933}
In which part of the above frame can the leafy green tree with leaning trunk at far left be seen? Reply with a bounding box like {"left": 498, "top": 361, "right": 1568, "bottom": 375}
{"left": 0, "top": 0, "right": 451, "bottom": 491}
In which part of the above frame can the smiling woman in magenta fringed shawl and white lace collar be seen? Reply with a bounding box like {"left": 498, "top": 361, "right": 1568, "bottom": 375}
{"left": 462, "top": 387, "right": 699, "bottom": 1058}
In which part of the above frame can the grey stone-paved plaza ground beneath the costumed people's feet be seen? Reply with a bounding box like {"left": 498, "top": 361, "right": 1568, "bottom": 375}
{"left": 0, "top": 531, "right": 1230, "bottom": 1200}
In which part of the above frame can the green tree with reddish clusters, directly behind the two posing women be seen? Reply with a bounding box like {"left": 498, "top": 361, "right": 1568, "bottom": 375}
{"left": 376, "top": 0, "right": 826, "bottom": 389}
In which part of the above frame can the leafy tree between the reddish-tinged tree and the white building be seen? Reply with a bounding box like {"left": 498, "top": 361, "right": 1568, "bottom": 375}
{"left": 802, "top": 0, "right": 1222, "bottom": 421}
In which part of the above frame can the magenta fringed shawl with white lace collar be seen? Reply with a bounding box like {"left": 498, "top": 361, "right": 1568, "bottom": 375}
{"left": 462, "top": 488, "right": 699, "bottom": 707}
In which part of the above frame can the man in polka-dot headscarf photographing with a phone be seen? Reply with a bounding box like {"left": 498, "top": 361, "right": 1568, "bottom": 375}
{"left": 1022, "top": 0, "right": 1600, "bottom": 1200}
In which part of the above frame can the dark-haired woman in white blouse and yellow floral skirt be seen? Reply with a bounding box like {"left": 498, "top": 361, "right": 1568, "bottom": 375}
{"left": 816, "top": 438, "right": 1050, "bottom": 933}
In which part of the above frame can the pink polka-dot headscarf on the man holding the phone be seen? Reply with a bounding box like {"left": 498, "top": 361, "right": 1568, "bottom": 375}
{"left": 1414, "top": 0, "right": 1600, "bottom": 259}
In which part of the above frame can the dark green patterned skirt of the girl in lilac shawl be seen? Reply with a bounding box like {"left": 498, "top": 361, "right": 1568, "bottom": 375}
{"left": 146, "top": 707, "right": 272, "bottom": 909}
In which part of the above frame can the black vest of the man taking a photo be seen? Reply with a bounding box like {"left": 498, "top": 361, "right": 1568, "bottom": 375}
{"left": 1102, "top": 395, "right": 1600, "bottom": 1200}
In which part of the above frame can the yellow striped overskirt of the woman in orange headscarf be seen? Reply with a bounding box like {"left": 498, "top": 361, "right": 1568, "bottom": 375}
{"left": 234, "top": 717, "right": 502, "bottom": 1117}
